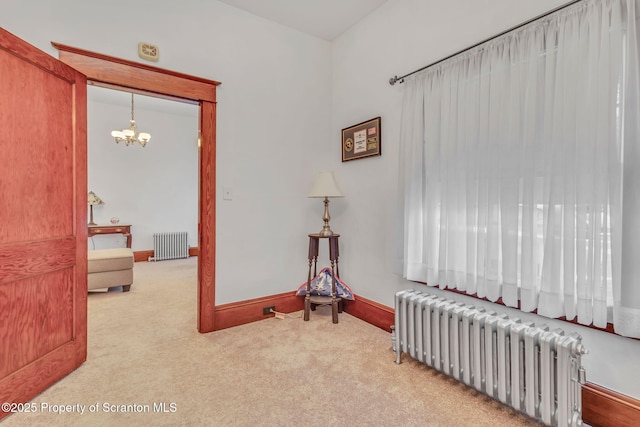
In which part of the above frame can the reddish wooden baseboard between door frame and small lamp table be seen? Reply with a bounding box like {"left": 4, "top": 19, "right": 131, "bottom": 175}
{"left": 214, "top": 291, "right": 304, "bottom": 331}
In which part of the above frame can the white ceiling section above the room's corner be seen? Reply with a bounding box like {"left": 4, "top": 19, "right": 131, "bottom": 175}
{"left": 220, "top": 0, "right": 387, "bottom": 41}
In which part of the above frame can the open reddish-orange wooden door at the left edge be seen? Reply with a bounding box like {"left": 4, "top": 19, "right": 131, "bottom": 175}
{"left": 0, "top": 28, "right": 87, "bottom": 418}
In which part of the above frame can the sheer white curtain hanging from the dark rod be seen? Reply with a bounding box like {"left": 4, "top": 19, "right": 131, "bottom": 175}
{"left": 400, "top": 0, "right": 640, "bottom": 337}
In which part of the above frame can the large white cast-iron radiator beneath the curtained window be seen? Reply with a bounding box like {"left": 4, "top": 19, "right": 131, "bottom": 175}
{"left": 392, "top": 290, "right": 587, "bottom": 426}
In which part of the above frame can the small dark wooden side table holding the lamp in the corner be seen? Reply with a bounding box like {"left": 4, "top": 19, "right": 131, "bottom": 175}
{"left": 304, "top": 234, "right": 341, "bottom": 323}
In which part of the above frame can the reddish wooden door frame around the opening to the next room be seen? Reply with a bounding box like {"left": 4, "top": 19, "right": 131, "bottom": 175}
{"left": 51, "top": 42, "right": 220, "bottom": 333}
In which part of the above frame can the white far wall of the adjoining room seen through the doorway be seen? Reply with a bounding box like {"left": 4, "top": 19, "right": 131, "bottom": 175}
{"left": 87, "top": 86, "right": 198, "bottom": 251}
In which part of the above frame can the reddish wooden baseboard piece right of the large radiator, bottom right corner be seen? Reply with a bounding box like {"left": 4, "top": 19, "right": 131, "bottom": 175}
{"left": 582, "top": 383, "right": 640, "bottom": 427}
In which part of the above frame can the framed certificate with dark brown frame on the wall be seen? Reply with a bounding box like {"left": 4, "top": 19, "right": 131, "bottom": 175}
{"left": 342, "top": 117, "right": 382, "bottom": 162}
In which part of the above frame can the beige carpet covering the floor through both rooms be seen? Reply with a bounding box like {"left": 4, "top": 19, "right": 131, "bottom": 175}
{"left": 0, "top": 258, "right": 538, "bottom": 427}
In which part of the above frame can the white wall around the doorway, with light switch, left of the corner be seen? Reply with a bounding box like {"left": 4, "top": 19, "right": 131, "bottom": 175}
{"left": 0, "top": 0, "right": 331, "bottom": 309}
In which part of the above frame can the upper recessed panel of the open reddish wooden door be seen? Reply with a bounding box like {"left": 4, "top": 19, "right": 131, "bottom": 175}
{"left": 0, "top": 51, "right": 74, "bottom": 245}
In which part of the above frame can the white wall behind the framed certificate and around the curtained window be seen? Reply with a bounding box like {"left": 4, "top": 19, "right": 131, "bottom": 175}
{"left": 331, "top": 0, "right": 640, "bottom": 398}
